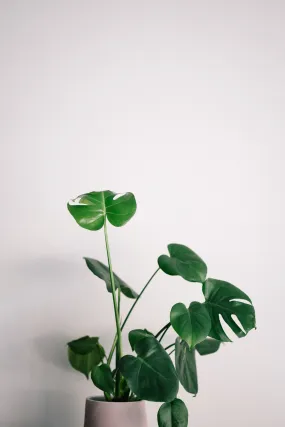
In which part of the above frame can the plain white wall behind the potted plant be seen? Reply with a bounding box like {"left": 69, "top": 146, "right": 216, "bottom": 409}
{"left": 0, "top": 0, "right": 285, "bottom": 427}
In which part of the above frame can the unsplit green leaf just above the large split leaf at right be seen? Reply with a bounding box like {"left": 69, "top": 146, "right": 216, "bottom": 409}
{"left": 158, "top": 243, "right": 207, "bottom": 283}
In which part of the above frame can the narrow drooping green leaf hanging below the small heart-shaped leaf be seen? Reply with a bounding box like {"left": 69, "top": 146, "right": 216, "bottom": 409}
{"left": 175, "top": 338, "right": 198, "bottom": 395}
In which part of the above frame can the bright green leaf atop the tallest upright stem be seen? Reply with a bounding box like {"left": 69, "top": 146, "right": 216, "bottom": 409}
{"left": 67, "top": 190, "right": 137, "bottom": 231}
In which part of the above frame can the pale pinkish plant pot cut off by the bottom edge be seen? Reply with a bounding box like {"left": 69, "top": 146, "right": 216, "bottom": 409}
{"left": 84, "top": 397, "right": 147, "bottom": 427}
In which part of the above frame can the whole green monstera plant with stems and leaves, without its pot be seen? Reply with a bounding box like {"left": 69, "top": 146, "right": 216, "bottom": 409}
{"left": 68, "top": 191, "right": 255, "bottom": 427}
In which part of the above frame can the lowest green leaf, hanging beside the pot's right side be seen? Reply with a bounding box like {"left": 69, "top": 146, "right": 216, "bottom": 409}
{"left": 157, "top": 399, "right": 188, "bottom": 427}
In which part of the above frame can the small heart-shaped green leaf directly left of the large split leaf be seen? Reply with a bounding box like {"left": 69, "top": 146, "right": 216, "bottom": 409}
{"left": 170, "top": 302, "right": 211, "bottom": 348}
